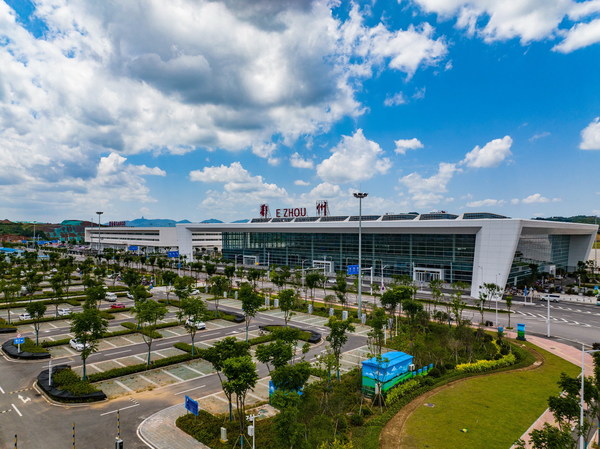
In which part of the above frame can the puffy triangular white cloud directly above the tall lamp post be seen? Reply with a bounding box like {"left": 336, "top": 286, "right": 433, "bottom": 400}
{"left": 317, "top": 129, "right": 392, "bottom": 183}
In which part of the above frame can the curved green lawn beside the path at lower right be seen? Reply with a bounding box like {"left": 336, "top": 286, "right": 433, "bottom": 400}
{"left": 398, "top": 342, "right": 579, "bottom": 449}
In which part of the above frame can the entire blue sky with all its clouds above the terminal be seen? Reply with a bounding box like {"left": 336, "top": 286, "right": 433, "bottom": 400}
{"left": 0, "top": 0, "right": 600, "bottom": 221}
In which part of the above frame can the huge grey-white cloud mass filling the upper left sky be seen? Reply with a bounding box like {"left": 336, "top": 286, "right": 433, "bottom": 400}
{"left": 0, "top": 0, "right": 447, "bottom": 217}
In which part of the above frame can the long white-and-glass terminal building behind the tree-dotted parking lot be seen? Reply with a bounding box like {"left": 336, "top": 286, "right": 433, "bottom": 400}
{"left": 86, "top": 212, "right": 598, "bottom": 296}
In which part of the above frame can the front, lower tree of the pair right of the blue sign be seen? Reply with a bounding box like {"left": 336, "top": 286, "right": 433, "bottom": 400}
{"left": 223, "top": 355, "right": 258, "bottom": 446}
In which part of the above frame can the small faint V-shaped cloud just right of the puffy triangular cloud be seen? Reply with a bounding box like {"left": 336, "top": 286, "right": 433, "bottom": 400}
{"left": 400, "top": 162, "right": 460, "bottom": 207}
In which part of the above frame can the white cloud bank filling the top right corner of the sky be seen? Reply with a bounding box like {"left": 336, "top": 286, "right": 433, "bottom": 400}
{"left": 413, "top": 0, "right": 600, "bottom": 53}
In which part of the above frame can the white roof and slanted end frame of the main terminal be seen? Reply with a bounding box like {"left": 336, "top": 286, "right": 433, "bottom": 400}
{"left": 176, "top": 214, "right": 598, "bottom": 297}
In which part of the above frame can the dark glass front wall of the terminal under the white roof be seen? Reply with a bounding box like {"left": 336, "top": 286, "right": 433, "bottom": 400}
{"left": 223, "top": 232, "right": 475, "bottom": 283}
